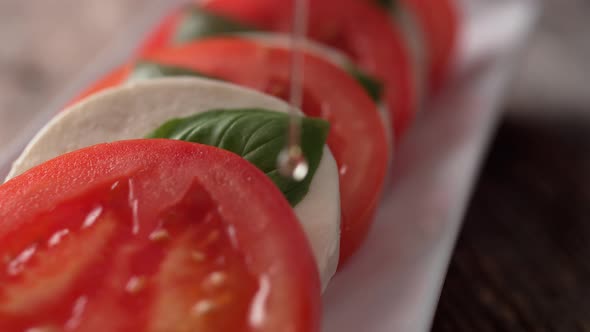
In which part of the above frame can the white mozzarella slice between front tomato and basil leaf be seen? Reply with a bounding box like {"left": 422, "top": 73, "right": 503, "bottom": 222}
{"left": 8, "top": 78, "right": 340, "bottom": 288}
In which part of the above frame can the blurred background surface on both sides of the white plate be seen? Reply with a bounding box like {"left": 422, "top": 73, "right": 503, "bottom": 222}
{"left": 0, "top": 0, "right": 590, "bottom": 332}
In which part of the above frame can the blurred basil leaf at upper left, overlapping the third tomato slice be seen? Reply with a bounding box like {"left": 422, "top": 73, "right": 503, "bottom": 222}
{"left": 172, "top": 6, "right": 257, "bottom": 44}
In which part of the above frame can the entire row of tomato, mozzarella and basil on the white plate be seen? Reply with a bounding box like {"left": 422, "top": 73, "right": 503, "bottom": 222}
{"left": 0, "top": 0, "right": 458, "bottom": 332}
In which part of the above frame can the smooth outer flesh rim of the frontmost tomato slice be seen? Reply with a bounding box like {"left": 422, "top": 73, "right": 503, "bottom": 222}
{"left": 0, "top": 140, "right": 320, "bottom": 331}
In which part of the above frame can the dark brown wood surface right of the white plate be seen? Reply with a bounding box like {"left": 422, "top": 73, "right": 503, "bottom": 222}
{"left": 433, "top": 112, "right": 590, "bottom": 332}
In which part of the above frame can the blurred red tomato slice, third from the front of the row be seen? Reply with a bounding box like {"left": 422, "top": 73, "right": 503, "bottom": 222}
{"left": 141, "top": 0, "right": 417, "bottom": 142}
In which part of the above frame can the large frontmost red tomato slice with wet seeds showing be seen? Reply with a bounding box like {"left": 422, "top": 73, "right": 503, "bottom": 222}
{"left": 0, "top": 140, "right": 320, "bottom": 332}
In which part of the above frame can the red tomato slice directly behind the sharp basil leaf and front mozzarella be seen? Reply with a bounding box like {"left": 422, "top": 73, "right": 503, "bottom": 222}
{"left": 75, "top": 38, "right": 388, "bottom": 264}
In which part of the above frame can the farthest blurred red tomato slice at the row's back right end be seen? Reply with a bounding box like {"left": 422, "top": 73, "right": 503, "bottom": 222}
{"left": 402, "top": 0, "right": 459, "bottom": 93}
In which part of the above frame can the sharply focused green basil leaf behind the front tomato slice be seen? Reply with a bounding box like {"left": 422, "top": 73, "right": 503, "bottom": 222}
{"left": 147, "top": 109, "right": 330, "bottom": 206}
